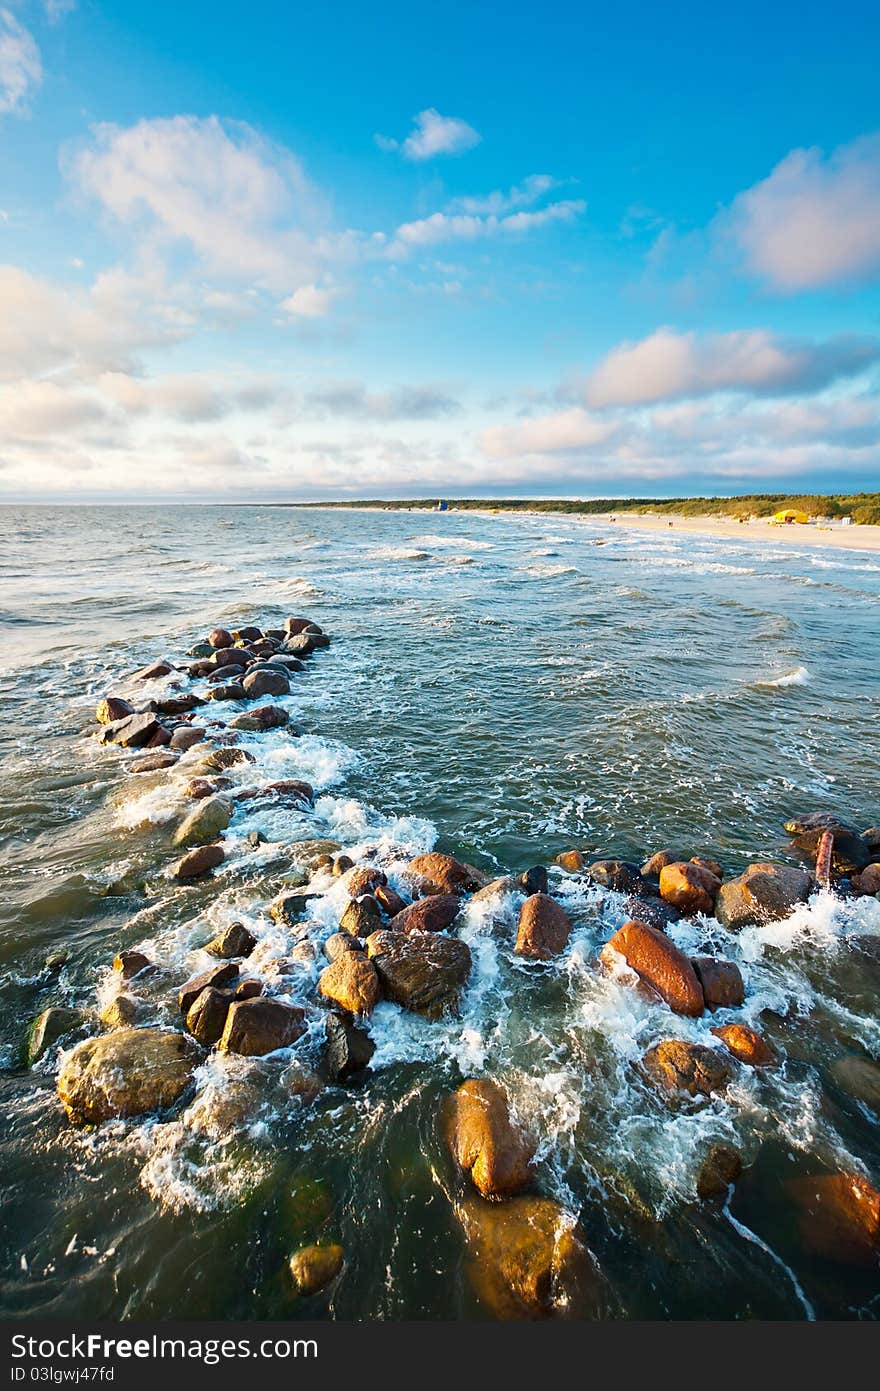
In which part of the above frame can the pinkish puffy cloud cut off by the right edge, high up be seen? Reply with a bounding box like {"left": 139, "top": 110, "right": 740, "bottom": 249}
{"left": 722, "top": 134, "right": 880, "bottom": 292}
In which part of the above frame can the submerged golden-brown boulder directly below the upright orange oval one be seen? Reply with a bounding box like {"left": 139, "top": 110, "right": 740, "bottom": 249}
{"left": 457, "top": 1193, "right": 595, "bottom": 1319}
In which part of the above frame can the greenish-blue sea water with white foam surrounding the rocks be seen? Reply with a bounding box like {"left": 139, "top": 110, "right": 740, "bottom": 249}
{"left": 0, "top": 506, "right": 880, "bottom": 1319}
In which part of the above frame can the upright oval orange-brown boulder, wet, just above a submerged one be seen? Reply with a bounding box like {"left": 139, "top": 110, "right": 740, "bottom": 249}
{"left": 446, "top": 1078, "right": 535, "bottom": 1198}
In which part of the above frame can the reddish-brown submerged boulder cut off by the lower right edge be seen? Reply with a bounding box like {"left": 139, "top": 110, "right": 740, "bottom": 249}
{"left": 788, "top": 1174, "right": 880, "bottom": 1270}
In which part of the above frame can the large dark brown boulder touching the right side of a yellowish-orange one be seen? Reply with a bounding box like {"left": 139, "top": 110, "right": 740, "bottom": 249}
{"left": 367, "top": 929, "right": 471, "bottom": 1020}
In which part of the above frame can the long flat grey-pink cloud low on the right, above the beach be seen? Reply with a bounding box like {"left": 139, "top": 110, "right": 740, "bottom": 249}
{"left": 584, "top": 328, "right": 880, "bottom": 408}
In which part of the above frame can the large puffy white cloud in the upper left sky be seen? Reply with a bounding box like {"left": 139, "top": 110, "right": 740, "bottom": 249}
{"left": 67, "top": 115, "right": 324, "bottom": 289}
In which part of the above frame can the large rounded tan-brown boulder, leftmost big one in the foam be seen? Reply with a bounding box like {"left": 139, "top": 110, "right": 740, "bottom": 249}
{"left": 58, "top": 1029, "right": 200, "bottom": 1125}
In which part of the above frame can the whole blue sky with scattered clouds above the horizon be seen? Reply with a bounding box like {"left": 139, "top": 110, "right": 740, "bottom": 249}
{"left": 0, "top": 0, "right": 880, "bottom": 502}
